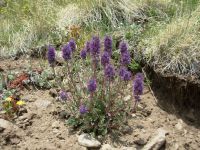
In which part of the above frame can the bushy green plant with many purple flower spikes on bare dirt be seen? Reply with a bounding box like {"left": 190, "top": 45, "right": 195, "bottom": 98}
{"left": 48, "top": 36, "right": 143, "bottom": 135}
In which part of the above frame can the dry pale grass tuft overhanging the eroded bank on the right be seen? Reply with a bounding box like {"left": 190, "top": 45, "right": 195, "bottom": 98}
{"left": 140, "top": 3, "right": 200, "bottom": 75}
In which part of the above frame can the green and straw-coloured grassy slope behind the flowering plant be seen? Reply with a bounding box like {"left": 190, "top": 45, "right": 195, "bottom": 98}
{"left": 0, "top": 0, "right": 200, "bottom": 74}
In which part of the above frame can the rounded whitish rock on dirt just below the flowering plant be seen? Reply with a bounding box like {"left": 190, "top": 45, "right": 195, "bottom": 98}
{"left": 78, "top": 133, "right": 101, "bottom": 148}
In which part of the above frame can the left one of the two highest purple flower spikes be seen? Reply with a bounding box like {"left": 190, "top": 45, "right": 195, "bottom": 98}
{"left": 90, "top": 36, "right": 101, "bottom": 57}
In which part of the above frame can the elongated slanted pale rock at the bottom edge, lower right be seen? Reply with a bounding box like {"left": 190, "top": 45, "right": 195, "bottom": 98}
{"left": 143, "top": 128, "right": 167, "bottom": 150}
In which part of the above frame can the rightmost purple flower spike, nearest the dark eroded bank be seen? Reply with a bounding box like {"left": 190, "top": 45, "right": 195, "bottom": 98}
{"left": 133, "top": 73, "right": 144, "bottom": 101}
